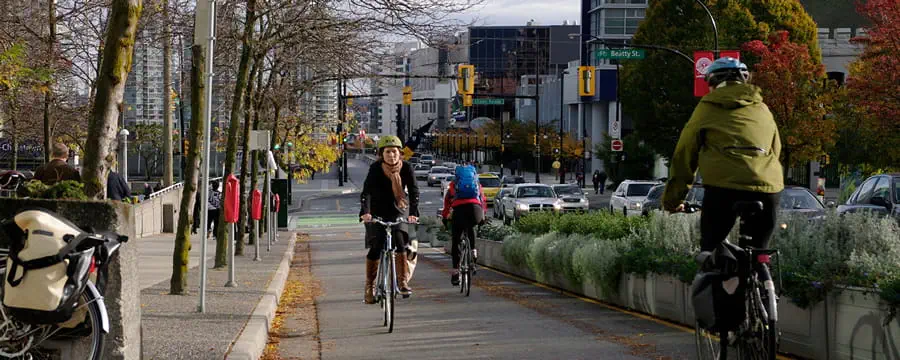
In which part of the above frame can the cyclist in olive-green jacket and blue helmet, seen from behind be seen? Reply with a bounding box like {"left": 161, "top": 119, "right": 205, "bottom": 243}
{"left": 663, "top": 57, "right": 784, "bottom": 251}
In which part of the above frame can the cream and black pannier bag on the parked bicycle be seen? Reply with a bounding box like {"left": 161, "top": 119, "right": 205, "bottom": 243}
{"left": 3, "top": 209, "right": 94, "bottom": 324}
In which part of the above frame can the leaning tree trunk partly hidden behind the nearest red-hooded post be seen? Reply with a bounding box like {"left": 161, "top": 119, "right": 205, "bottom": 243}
{"left": 215, "top": 0, "right": 256, "bottom": 268}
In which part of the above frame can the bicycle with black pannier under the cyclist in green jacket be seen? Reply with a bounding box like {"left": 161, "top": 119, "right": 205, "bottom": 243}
{"left": 692, "top": 201, "right": 779, "bottom": 360}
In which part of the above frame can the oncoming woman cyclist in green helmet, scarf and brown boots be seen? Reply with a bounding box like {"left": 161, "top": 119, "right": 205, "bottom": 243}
{"left": 359, "top": 135, "right": 419, "bottom": 304}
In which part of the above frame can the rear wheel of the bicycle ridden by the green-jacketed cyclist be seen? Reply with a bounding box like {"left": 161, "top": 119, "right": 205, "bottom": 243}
{"left": 737, "top": 283, "right": 777, "bottom": 360}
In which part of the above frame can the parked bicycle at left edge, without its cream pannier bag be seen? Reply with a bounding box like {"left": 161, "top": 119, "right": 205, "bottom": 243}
{"left": 0, "top": 211, "right": 128, "bottom": 360}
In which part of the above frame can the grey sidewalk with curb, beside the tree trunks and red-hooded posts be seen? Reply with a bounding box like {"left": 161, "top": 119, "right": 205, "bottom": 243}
{"left": 141, "top": 231, "right": 295, "bottom": 360}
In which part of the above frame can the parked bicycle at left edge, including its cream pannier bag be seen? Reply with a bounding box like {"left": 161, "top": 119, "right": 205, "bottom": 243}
{"left": 0, "top": 209, "right": 128, "bottom": 360}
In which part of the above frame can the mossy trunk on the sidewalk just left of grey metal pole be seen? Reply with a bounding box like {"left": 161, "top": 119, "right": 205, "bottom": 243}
{"left": 169, "top": 45, "right": 207, "bottom": 295}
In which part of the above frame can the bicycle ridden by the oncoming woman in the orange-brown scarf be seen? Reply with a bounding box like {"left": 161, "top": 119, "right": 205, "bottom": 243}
{"left": 371, "top": 217, "right": 409, "bottom": 333}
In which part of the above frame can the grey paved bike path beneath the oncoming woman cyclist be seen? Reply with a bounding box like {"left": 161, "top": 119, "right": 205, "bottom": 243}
{"left": 304, "top": 216, "right": 694, "bottom": 359}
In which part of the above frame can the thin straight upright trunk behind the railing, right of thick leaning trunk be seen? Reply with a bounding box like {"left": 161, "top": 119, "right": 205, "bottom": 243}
{"left": 162, "top": 0, "right": 175, "bottom": 187}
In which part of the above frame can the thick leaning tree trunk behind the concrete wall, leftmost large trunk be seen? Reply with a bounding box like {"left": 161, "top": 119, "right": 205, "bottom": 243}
{"left": 81, "top": 0, "right": 141, "bottom": 200}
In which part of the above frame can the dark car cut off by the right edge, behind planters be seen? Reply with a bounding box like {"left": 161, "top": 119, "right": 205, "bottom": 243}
{"left": 829, "top": 173, "right": 900, "bottom": 219}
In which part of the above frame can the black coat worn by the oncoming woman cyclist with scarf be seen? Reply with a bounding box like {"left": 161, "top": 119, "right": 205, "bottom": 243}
{"left": 359, "top": 160, "right": 419, "bottom": 247}
